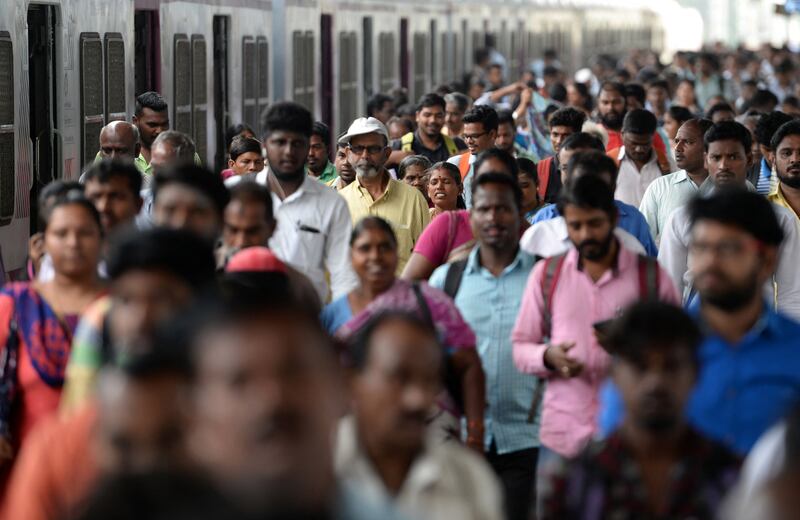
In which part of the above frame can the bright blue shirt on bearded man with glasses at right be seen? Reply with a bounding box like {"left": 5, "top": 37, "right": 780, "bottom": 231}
{"left": 601, "top": 305, "right": 800, "bottom": 455}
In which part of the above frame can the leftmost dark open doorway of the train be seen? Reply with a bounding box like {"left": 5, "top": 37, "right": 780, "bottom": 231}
{"left": 28, "top": 4, "right": 61, "bottom": 233}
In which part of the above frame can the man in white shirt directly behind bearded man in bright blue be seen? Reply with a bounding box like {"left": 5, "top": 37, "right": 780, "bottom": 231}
{"left": 658, "top": 121, "right": 800, "bottom": 318}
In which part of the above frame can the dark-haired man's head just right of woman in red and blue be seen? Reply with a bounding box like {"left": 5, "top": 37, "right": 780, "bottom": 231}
{"left": 83, "top": 159, "right": 143, "bottom": 236}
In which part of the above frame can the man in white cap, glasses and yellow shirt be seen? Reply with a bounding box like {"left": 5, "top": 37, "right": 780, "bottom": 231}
{"left": 339, "top": 117, "right": 430, "bottom": 275}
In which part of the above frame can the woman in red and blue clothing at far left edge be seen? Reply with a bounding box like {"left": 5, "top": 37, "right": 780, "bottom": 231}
{"left": 0, "top": 192, "right": 103, "bottom": 496}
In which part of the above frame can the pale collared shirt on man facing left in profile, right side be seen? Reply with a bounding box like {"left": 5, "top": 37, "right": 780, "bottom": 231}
{"left": 639, "top": 170, "right": 714, "bottom": 242}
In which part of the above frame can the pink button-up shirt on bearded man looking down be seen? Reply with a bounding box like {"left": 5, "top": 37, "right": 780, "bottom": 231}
{"left": 511, "top": 248, "right": 680, "bottom": 457}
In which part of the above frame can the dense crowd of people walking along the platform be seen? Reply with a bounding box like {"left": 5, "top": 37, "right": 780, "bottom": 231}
{"left": 0, "top": 40, "right": 800, "bottom": 520}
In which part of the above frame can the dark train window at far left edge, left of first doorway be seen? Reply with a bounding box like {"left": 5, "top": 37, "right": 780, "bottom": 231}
{"left": 0, "top": 31, "right": 16, "bottom": 226}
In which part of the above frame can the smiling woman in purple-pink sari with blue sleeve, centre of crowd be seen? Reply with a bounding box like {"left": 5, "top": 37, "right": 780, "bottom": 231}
{"left": 321, "top": 217, "right": 485, "bottom": 452}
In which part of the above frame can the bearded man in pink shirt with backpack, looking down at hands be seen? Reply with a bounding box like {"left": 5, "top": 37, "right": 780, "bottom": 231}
{"left": 511, "top": 175, "right": 679, "bottom": 457}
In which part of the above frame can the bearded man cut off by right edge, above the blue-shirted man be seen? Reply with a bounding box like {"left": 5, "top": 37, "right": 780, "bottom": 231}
{"left": 767, "top": 120, "right": 800, "bottom": 217}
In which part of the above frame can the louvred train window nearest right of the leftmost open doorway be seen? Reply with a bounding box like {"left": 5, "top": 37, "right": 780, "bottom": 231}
{"left": 80, "top": 33, "right": 105, "bottom": 164}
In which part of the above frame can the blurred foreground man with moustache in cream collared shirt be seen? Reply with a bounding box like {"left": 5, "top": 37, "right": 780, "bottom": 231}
{"left": 336, "top": 312, "right": 502, "bottom": 520}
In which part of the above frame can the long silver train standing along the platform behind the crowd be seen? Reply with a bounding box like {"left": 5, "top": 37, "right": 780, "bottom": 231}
{"left": 0, "top": 0, "right": 667, "bottom": 277}
